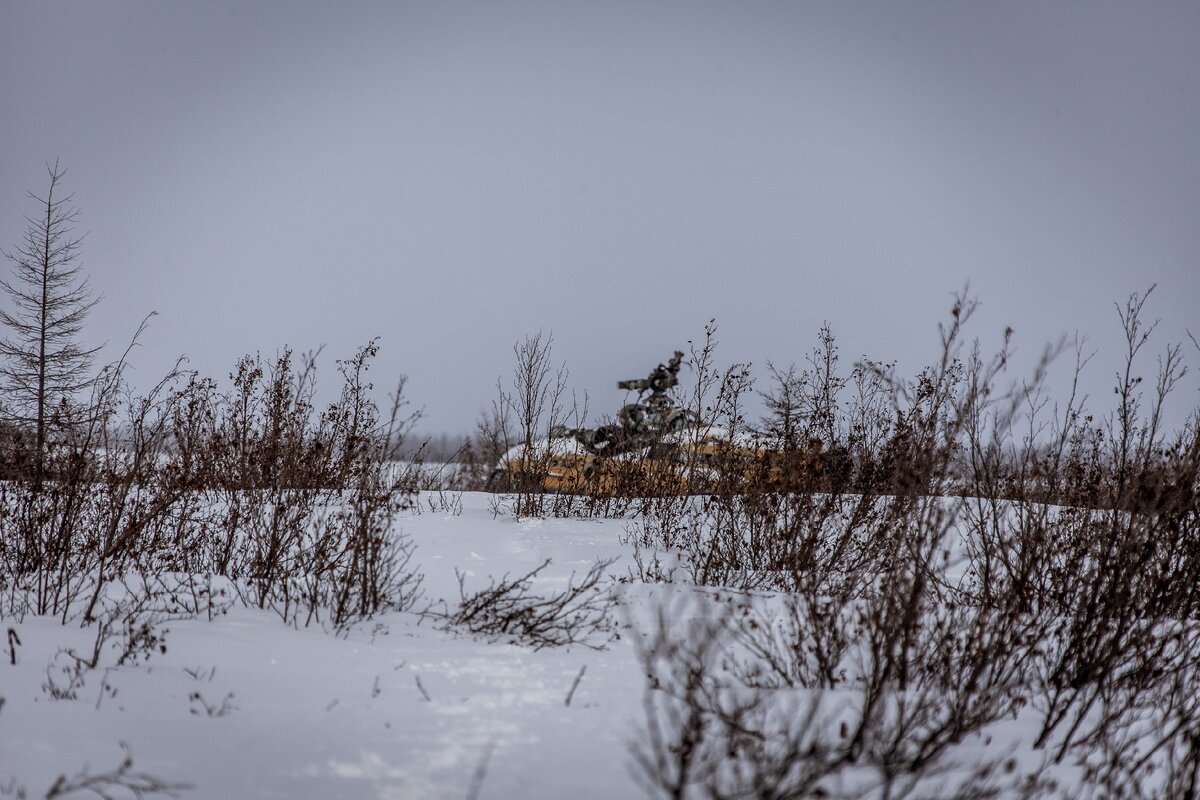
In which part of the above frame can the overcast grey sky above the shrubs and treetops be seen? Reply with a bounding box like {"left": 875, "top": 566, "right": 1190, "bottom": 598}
{"left": 0, "top": 0, "right": 1200, "bottom": 432}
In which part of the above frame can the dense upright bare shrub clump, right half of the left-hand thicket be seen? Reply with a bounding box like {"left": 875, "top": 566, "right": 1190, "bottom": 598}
{"left": 207, "top": 342, "right": 421, "bottom": 627}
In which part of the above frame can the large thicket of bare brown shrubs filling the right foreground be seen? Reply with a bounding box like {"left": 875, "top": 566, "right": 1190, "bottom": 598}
{"left": 630, "top": 295, "right": 1200, "bottom": 796}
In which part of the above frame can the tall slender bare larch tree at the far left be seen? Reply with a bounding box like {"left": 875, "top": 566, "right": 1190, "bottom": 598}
{"left": 0, "top": 161, "right": 100, "bottom": 483}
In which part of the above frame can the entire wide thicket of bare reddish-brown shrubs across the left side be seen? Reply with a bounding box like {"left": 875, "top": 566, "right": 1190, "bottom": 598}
{"left": 0, "top": 342, "right": 420, "bottom": 627}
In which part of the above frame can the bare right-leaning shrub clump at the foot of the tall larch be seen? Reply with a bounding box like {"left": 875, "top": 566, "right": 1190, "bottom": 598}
{"left": 0, "top": 324, "right": 192, "bottom": 621}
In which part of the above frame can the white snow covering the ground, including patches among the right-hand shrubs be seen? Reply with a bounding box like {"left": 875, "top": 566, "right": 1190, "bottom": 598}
{"left": 7, "top": 493, "right": 1190, "bottom": 800}
